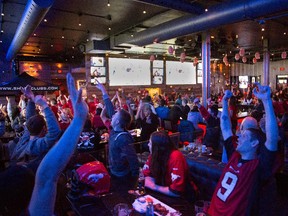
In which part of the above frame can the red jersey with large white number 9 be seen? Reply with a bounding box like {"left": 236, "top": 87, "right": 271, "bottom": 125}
{"left": 208, "top": 152, "right": 259, "bottom": 216}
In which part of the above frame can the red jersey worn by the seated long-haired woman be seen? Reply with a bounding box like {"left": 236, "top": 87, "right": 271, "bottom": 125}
{"left": 143, "top": 150, "right": 189, "bottom": 193}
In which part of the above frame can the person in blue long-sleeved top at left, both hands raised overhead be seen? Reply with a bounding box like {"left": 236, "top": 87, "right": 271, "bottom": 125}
{"left": 11, "top": 85, "right": 61, "bottom": 173}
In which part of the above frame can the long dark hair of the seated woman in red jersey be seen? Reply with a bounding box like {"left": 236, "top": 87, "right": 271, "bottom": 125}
{"left": 150, "top": 131, "right": 175, "bottom": 186}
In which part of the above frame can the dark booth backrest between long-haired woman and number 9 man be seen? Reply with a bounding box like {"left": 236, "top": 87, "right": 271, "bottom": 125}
{"left": 183, "top": 152, "right": 225, "bottom": 201}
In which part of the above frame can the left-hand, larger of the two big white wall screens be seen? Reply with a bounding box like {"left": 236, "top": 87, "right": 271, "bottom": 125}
{"left": 109, "top": 58, "right": 151, "bottom": 86}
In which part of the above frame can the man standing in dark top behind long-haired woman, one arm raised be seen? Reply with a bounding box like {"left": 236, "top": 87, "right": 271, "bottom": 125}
{"left": 96, "top": 80, "right": 139, "bottom": 178}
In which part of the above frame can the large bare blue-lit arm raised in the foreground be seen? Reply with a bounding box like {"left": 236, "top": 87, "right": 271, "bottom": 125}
{"left": 28, "top": 73, "right": 88, "bottom": 216}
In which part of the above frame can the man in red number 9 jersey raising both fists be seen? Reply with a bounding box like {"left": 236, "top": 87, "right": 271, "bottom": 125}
{"left": 208, "top": 84, "right": 278, "bottom": 216}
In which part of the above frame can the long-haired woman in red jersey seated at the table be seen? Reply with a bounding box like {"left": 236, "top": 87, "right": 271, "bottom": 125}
{"left": 143, "top": 131, "right": 189, "bottom": 197}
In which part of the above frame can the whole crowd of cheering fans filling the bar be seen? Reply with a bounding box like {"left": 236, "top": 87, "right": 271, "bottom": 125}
{"left": 0, "top": 74, "right": 288, "bottom": 216}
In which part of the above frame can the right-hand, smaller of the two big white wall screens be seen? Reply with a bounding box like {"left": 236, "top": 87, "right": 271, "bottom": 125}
{"left": 166, "top": 61, "right": 196, "bottom": 85}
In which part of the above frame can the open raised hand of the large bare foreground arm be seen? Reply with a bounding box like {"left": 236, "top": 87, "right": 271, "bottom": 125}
{"left": 67, "top": 73, "right": 88, "bottom": 119}
